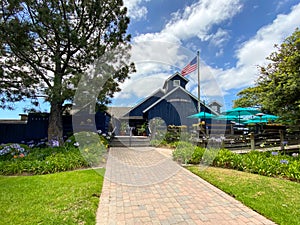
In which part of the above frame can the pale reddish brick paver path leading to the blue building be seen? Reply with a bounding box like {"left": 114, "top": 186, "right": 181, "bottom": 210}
{"left": 97, "top": 148, "right": 275, "bottom": 225}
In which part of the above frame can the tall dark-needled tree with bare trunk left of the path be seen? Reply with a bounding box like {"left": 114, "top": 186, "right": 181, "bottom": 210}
{"left": 0, "top": 0, "right": 134, "bottom": 141}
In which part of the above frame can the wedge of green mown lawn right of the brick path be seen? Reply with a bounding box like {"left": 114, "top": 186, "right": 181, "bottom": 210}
{"left": 188, "top": 166, "right": 300, "bottom": 225}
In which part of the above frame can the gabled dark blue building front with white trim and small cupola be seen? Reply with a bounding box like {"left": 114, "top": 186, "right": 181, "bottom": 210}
{"left": 122, "top": 73, "right": 218, "bottom": 133}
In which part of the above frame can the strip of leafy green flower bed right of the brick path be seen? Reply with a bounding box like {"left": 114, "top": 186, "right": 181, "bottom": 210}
{"left": 173, "top": 144, "right": 300, "bottom": 182}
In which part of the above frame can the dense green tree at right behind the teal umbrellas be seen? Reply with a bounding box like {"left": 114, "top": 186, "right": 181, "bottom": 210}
{"left": 235, "top": 29, "right": 300, "bottom": 124}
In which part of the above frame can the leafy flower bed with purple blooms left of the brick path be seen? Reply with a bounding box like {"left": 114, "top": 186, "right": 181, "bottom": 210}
{"left": 0, "top": 132, "right": 108, "bottom": 175}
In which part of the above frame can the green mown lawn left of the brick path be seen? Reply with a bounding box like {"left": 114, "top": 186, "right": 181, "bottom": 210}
{"left": 0, "top": 169, "right": 104, "bottom": 225}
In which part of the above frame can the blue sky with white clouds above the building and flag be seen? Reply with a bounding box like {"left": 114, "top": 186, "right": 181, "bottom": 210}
{"left": 0, "top": 0, "right": 300, "bottom": 118}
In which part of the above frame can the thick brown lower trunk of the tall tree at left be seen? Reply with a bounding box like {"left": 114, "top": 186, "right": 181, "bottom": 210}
{"left": 48, "top": 102, "right": 64, "bottom": 145}
